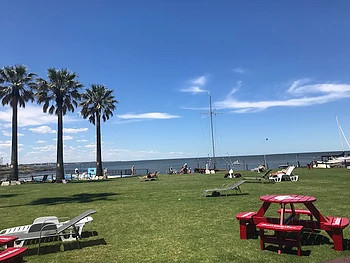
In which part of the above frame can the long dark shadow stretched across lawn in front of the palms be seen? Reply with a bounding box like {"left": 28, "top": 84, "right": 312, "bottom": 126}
{"left": 29, "top": 193, "right": 117, "bottom": 205}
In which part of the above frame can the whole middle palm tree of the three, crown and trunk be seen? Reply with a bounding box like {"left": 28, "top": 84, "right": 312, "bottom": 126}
{"left": 36, "top": 68, "right": 83, "bottom": 183}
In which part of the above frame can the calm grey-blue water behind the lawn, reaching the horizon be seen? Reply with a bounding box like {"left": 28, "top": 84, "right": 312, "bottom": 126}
{"left": 65, "top": 152, "right": 348, "bottom": 173}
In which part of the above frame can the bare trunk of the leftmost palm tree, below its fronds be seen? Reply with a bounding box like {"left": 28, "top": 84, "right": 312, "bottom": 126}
{"left": 9, "top": 104, "right": 18, "bottom": 181}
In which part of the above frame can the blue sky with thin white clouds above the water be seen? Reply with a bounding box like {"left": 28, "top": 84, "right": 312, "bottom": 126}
{"left": 0, "top": 0, "right": 350, "bottom": 163}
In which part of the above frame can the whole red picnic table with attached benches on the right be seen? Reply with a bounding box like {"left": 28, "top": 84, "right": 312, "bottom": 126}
{"left": 236, "top": 195, "right": 349, "bottom": 254}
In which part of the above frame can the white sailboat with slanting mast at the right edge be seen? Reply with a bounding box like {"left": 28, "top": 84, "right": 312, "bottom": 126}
{"left": 313, "top": 117, "right": 350, "bottom": 168}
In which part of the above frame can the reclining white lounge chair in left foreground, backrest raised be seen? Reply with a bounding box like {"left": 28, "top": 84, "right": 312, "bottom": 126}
{"left": 9, "top": 209, "right": 96, "bottom": 254}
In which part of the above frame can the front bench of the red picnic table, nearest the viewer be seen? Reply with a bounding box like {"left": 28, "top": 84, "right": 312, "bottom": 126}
{"left": 256, "top": 222, "right": 304, "bottom": 256}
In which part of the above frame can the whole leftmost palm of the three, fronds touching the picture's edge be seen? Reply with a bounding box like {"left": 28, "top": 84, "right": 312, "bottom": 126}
{"left": 0, "top": 65, "right": 36, "bottom": 181}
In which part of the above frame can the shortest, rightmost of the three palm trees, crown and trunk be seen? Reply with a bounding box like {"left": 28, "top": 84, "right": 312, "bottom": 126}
{"left": 80, "top": 84, "right": 118, "bottom": 176}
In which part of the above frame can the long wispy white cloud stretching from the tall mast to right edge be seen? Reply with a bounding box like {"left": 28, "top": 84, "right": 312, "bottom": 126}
{"left": 215, "top": 79, "right": 350, "bottom": 113}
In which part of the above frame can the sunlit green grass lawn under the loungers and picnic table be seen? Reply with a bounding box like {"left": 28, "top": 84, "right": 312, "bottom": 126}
{"left": 0, "top": 168, "right": 350, "bottom": 263}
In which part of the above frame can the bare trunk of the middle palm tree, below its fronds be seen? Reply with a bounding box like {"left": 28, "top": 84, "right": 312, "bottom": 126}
{"left": 56, "top": 106, "right": 64, "bottom": 183}
